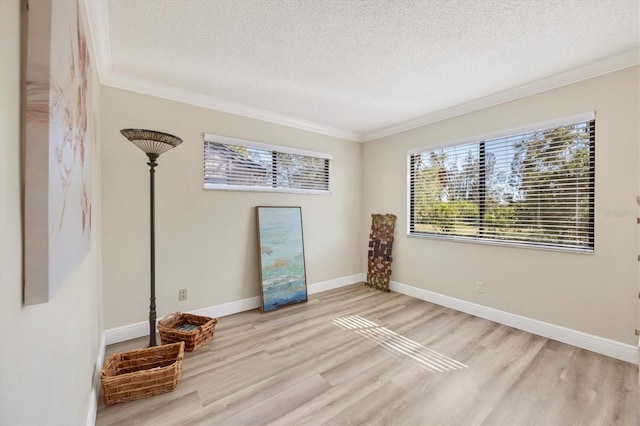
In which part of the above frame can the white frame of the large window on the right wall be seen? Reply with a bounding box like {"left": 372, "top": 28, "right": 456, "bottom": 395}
{"left": 406, "top": 111, "right": 596, "bottom": 254}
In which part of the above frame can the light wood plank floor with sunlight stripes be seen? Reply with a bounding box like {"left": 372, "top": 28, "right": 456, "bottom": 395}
{"left": 96, "top": 284, "right": 640, "bottom": 426}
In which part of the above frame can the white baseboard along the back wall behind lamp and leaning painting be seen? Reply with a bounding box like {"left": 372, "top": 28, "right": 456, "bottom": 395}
{"left": 104, "top": 274, "right": 365, "bottom": 345}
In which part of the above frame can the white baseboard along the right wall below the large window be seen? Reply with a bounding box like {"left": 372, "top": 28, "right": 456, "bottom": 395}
{"left": 389, "top": 281, "right": 638, "bottom": 364}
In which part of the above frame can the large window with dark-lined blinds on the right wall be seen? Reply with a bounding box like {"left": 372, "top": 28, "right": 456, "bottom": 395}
{"left": 408, "top": 112, "right": 595, "bottom": 252}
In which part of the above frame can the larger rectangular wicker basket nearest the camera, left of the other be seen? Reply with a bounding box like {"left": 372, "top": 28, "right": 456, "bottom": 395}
{"left": 101, "top": 343, "right": 184, "bottom": 405}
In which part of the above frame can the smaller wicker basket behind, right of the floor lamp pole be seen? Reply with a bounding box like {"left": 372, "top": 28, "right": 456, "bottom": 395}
{"left": 158, "top": 312, "right": 218, "bottom": 352}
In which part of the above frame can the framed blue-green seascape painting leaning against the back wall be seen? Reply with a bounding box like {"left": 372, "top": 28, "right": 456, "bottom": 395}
{"left": 256, "top": 207, "right": 307, "bottom": 313}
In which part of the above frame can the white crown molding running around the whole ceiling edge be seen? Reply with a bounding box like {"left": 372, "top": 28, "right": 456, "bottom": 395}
{"left": 84, "top": 0, "right": 640, "bottom": 142}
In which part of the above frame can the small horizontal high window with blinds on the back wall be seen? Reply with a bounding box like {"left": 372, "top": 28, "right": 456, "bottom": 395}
{"left": 204, "top": 134, "right": 332, "bottom": 194}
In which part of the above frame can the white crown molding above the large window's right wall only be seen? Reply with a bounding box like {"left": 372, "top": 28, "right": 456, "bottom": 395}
{"left": 361, "top": 49, "right": 640, "bottom": 142}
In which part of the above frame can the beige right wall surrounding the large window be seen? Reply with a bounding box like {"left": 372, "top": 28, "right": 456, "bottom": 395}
{"left": 362, "top": 67, "right": 640, "bottom": 344}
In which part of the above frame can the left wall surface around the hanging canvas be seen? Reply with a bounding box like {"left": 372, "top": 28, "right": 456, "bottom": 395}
{"left": 0, "top": 0, "right": 102, "bottom": 424}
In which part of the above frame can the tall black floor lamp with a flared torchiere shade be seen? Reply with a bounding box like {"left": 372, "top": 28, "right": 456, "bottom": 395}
{"left": 120, "top": 129, "right": 182, "bottom": 347}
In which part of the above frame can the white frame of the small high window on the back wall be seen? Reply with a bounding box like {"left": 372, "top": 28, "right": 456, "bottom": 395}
{"left": 202, "top": 133, "right": 333, "bottom": 195}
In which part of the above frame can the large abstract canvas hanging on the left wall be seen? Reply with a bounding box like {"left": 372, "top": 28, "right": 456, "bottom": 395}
{"left": 23, "top": 0, "right": 94, "bottom": 304}
